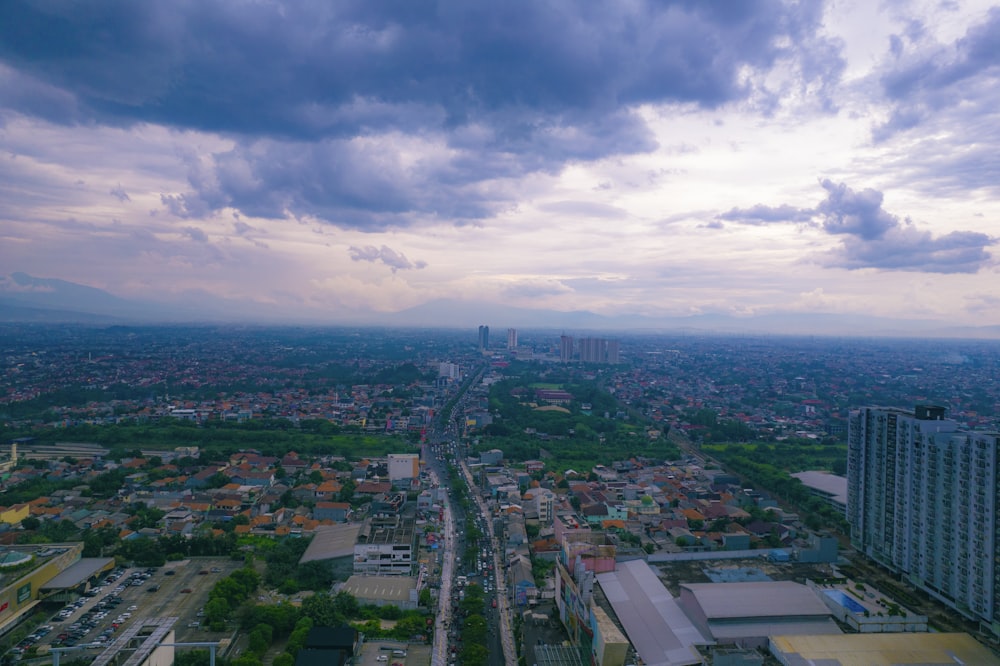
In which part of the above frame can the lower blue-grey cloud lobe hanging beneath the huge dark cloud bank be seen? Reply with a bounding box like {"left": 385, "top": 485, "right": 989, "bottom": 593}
{"left": 160, "top": 139, "right": 522, "bottom": 230}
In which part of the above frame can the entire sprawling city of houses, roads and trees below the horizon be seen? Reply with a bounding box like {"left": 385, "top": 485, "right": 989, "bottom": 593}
{"left": 0, "top": 324, "right": 1000, "bottom": 666}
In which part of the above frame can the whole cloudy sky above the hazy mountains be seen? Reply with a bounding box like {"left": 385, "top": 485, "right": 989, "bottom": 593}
{"left": 0, "top": 0, "right": 1000, "bottom": 326}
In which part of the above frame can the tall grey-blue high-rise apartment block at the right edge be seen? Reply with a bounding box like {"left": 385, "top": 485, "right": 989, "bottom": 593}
{"left": 847, "top": 405, "right": 1000, "bottom": 634}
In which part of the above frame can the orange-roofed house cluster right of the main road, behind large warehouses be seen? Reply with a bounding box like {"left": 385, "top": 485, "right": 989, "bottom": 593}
{"left": 479, "top": 452, "right": 836, "bottom": 568}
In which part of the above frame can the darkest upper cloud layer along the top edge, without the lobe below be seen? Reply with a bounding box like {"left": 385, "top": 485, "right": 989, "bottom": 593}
{"left": 0, "top": 0, "right": 825, "bottom": 137}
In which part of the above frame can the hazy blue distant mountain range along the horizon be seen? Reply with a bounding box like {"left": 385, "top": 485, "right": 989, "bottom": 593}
{"left": 0, "top": 273, "right": 1000, "bottom": 339}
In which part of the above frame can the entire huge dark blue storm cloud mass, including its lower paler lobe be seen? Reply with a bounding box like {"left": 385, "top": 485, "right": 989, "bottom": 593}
{"left": 0, "top": 0, "right": 843, "bottom": 228}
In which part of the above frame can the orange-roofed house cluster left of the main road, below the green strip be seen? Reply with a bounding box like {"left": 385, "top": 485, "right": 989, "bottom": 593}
{"left": 0, "top": 448, "right": 419, "bottom": 539}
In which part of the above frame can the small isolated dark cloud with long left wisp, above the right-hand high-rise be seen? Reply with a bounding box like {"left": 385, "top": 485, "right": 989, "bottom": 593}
{"left": 716, "top": 179, "right": 1000, "bottom": 273}
